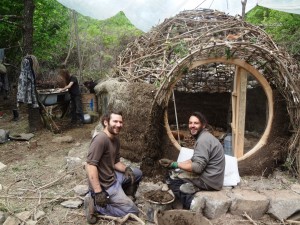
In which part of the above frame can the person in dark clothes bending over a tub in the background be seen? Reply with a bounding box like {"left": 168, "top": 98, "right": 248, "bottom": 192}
{"left": 59, "top": 69, "right": 84, "bottom": 124}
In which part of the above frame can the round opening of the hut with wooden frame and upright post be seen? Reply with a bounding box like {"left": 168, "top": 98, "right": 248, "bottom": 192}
{"left": 164, "top": 59, "right": 273, "bottom": 160}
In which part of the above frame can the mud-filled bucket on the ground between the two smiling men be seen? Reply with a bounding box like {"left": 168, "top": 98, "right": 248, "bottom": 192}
{"left": 144, "top": 190, "right": 175, "bottom": 223}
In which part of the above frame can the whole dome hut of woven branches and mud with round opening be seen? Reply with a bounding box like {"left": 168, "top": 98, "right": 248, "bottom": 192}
{"left": 96, "top": 9, "right": 300, "bottom": 175}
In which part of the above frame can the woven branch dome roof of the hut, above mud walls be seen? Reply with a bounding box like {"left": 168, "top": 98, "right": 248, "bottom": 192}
{"left": 115, "top": 9, "right": 300, "bottom": 172}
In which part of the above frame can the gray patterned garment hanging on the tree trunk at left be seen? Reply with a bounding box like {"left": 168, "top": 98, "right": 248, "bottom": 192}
{"left": 17, "top": 56, "right": 39, "bottom": 108}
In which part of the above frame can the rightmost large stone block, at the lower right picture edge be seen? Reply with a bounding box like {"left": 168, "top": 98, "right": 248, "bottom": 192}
{"left": 264, "top": 190, "right": 300, "bottom": 220}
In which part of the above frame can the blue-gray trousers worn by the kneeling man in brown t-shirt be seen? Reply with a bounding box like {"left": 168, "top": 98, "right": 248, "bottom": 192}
{"left": 89, "top": 168, "right": 142, "bottom": 217}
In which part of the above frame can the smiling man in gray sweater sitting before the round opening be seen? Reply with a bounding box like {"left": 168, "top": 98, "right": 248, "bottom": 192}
{"left": 159, "top": 112, "right": 225, "bottom": 209}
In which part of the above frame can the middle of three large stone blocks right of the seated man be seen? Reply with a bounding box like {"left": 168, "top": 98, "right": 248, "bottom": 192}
{"left": 229, "top": 189, "right": 269, "bottom": 219}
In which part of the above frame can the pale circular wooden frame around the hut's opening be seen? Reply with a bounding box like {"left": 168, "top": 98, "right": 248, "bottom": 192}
{"left": 164, "top": 58, "right": 274, "bottom": 161}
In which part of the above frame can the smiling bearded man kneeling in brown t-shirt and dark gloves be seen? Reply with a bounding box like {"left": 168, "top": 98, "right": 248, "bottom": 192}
{"left": 84, "top": 111, "right": 142, "bottom": 224}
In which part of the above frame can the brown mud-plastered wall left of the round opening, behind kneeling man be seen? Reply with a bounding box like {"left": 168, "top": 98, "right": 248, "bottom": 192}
{"left": 95, "top": 79, "right": 157, "bottom": 162}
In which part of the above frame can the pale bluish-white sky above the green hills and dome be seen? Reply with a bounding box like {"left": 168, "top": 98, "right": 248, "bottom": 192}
{"left": 58, "top": 0, "right": 257, "bottom": 32}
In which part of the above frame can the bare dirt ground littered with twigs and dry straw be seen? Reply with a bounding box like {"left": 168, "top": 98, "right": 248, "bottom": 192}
{"left": 0, "top": 105, "right": 296, "bottom": 225}
